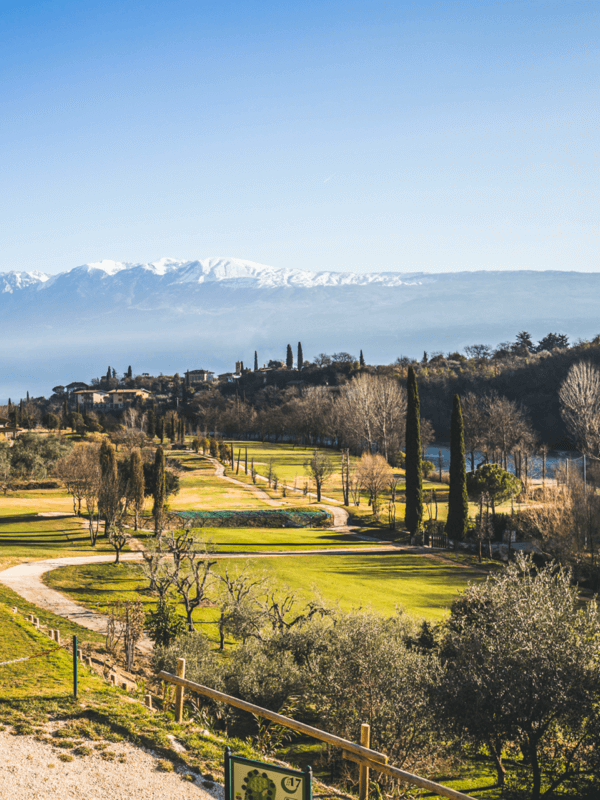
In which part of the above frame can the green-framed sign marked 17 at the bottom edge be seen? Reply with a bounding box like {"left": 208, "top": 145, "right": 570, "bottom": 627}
{"left": 225, "top": 747, "right": 312, "bottom": 800}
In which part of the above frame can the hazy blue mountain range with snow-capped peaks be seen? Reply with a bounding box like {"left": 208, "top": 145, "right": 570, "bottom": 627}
{"left": 0, "top": 258, "right": 600, "bottom": 400}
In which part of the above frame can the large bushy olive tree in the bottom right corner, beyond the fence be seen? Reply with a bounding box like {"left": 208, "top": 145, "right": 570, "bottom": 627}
{"left": 441, "top": 554, "right": 600, "bottom": 800}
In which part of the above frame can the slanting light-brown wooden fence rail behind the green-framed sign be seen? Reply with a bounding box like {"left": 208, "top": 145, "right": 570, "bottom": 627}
{"left": 158, "top": 666, "right": 475, "bottom": 800}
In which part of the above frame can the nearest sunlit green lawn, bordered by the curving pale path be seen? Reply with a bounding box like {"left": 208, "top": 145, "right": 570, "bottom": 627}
{"left": 44, "top": 553, "right": 483, "bottom": 623}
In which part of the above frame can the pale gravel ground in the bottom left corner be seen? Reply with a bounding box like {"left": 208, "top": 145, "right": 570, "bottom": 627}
{"left": 0, "top": 731, "right": 224, "bottom": 800}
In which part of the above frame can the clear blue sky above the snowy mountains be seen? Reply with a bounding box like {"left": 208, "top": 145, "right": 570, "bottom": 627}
{"left": 0, "top": 0, "right": 600, "bottom": 272}
